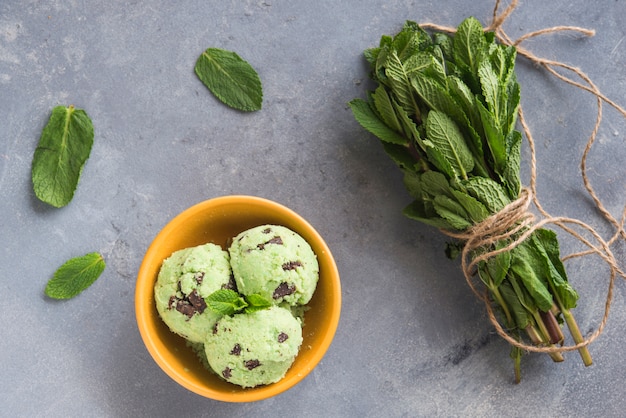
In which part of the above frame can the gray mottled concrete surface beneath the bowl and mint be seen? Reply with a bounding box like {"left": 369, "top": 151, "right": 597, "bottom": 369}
{"left": 0, "top": 0, "right": 626, "bottom": 417}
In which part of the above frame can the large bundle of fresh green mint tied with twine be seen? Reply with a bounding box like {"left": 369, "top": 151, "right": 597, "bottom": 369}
{"left": 350, "top": 18, "right": 592, "bottom": 382}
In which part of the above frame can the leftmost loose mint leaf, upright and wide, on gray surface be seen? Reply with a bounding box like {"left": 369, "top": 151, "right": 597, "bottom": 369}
{"left": 31, "top": 105, "right": 94, "bottom": 208}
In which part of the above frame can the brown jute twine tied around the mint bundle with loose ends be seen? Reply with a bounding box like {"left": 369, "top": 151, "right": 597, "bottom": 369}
{"left": 420, "top": 0, "right": 626, "bottom": 353}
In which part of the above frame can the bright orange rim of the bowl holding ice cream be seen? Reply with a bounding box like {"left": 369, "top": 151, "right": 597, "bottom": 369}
{"left": 135, "top": 195, "right": 341, "bottom": 402}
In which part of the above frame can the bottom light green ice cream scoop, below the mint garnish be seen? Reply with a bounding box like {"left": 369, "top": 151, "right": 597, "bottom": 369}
{"left": 204, "top": 306, "right": 302, "bottom": 387}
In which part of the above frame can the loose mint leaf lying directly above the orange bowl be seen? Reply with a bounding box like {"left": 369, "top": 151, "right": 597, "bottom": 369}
{"left": 195, "top": 48, "right": 263, "bottom": 112}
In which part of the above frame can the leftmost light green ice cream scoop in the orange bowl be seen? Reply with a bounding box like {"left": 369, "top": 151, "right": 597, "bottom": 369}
{"left": 154, "top": 244, "right": 234, "bottom": 343}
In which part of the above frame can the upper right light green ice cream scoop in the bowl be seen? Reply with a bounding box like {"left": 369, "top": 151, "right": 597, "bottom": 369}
{"left": 228, "top": 225, "right": 319, "bottom": 305}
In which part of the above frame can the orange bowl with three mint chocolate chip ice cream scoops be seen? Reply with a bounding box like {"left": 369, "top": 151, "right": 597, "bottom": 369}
{"left": 135, "top": 195, "right": 341, "bottom": 402}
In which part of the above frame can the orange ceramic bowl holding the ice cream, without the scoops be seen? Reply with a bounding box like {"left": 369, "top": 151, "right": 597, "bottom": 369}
{"left": 135, "top": 196, "right": 341, "bottom": 402}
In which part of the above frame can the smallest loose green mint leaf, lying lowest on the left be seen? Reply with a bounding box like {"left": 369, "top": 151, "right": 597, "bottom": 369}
{"left": 45, "top": 253, "right": 106, "bottom": 299}
